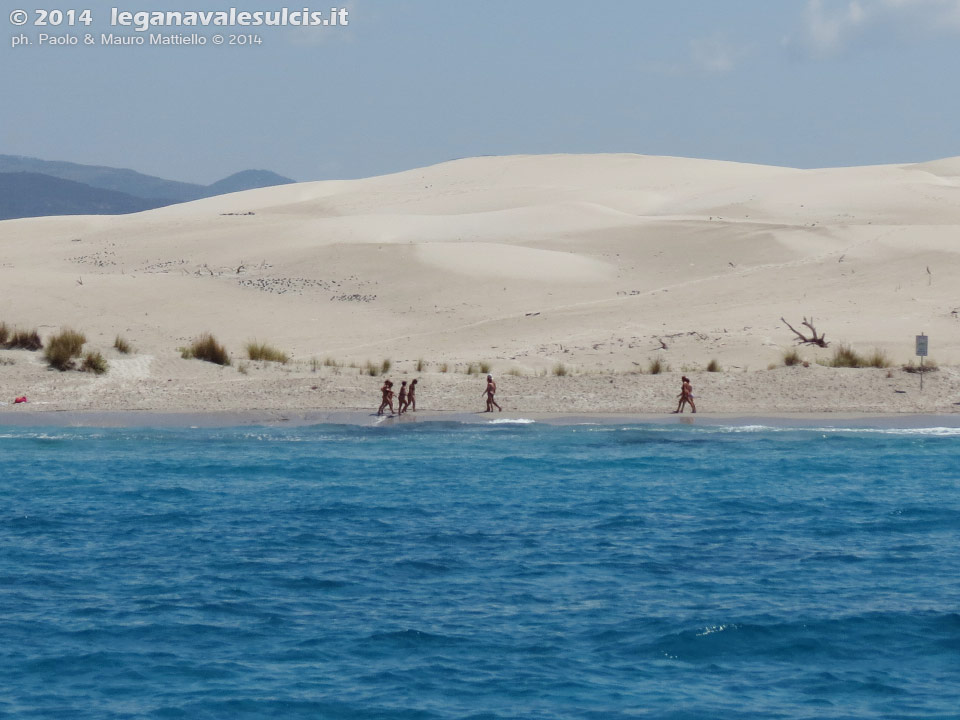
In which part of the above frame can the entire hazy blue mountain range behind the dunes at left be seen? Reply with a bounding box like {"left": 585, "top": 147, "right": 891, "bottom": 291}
{"left": 0, "top": 155, "right": 296, "bottom": 220}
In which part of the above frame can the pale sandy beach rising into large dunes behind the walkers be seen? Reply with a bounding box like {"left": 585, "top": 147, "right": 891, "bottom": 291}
{"left": 0, "top": 155, "right": 960, "bottom": 418}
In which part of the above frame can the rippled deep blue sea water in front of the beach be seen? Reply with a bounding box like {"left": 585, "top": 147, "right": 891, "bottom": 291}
{"left": 0, "top": 423, "right": 960, "bottom": 720}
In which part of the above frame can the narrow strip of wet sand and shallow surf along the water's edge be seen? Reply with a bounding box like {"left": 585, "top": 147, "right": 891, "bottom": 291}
{"left": 0, "top": 410, "right": 960, "bottom": 429}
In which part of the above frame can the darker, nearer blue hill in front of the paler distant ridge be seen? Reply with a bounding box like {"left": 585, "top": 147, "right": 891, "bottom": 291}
{"left": 0, "top": 172, "right": 170, "bottom": 220}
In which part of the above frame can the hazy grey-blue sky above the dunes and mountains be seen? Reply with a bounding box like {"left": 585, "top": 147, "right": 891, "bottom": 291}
{"left": 0, "top": 0, "right": 960, "bottom": 183}
